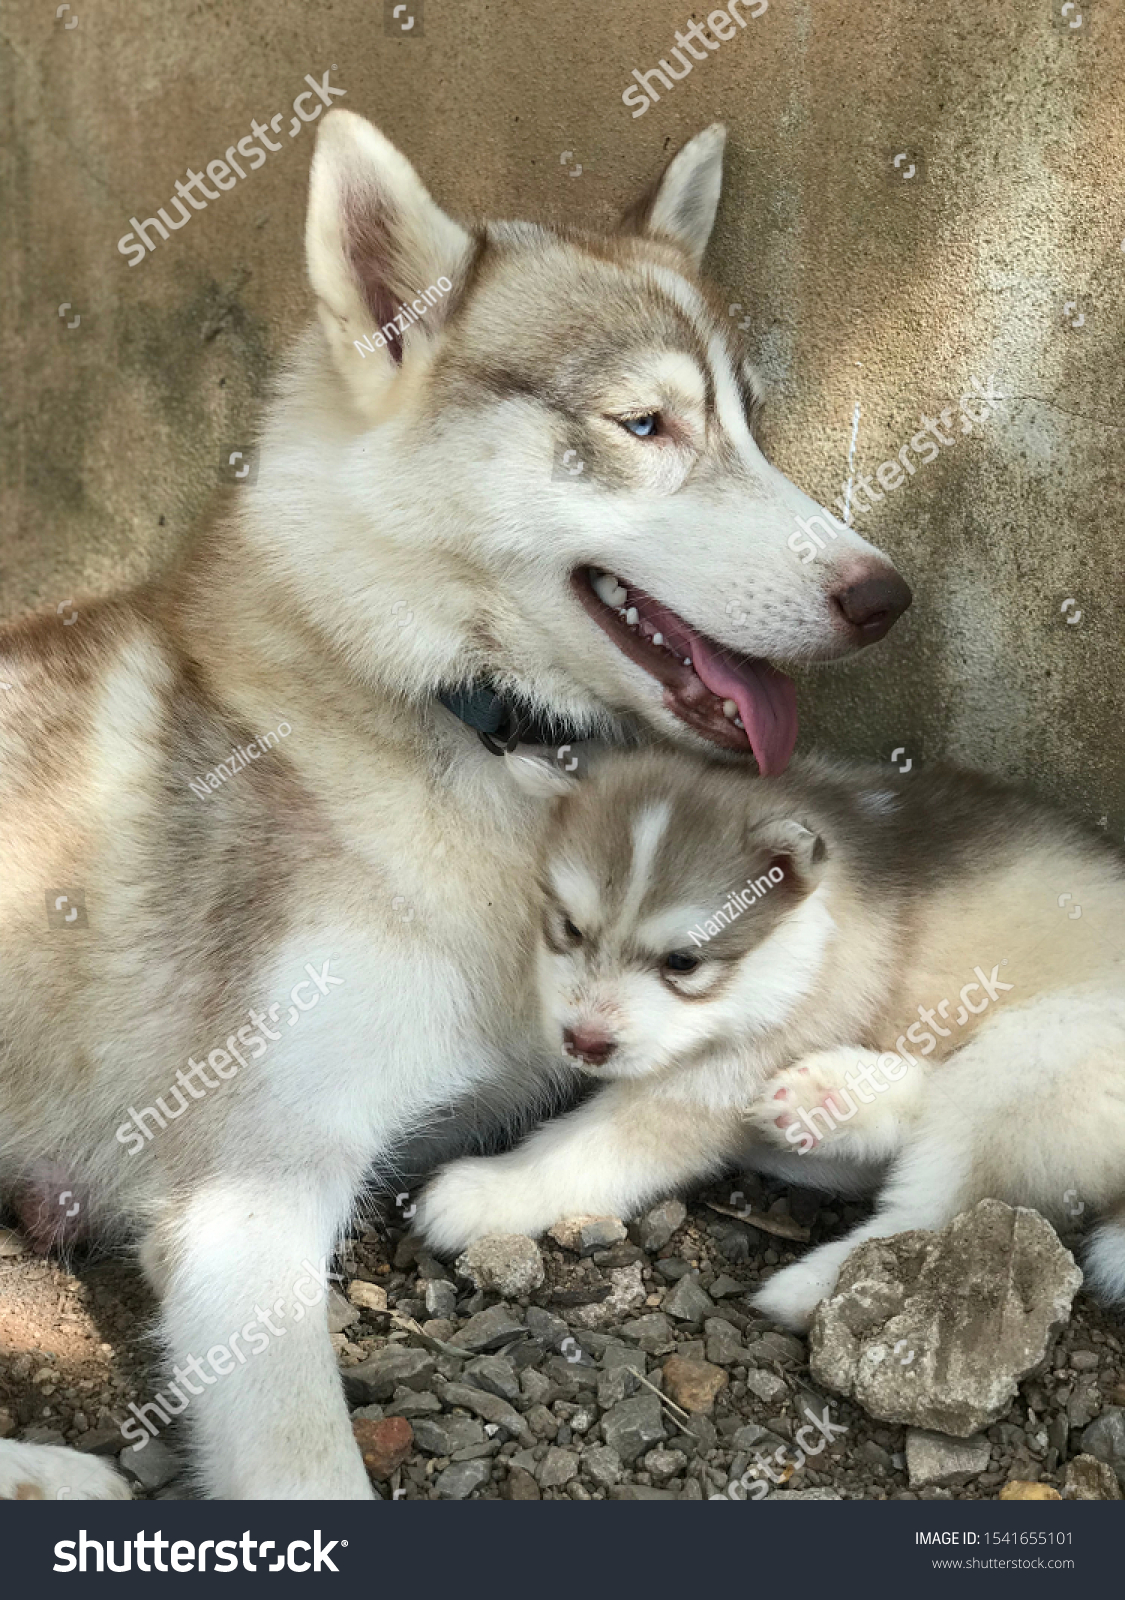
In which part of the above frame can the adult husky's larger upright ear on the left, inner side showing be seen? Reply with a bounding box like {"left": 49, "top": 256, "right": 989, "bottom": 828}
{"left": 306, "top": 107, "right": 474, "bottom": 402}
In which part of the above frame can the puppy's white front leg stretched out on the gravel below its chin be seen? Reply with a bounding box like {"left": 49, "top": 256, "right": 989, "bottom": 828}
{"left": 418, "top": 1083, "right": 743, "bottom": 1251}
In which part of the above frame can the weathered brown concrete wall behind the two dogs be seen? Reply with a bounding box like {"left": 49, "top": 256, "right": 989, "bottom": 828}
{"left": 0, "top": 0, "right": 1125, "bottom": 819}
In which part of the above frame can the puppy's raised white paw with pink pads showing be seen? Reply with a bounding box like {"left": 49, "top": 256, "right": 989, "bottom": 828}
{"left": 746, "top": 1045, "right": 925, "bottom": 1163}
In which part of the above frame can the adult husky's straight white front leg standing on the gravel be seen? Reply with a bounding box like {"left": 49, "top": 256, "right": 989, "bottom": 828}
{"left": 152, "top": 1173, "right": 371, "bottom": 1499}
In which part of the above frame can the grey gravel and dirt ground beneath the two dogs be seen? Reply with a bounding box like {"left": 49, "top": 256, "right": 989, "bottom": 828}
{"left": 0, "top": 1178, "right": 1125, "bottom": 1501}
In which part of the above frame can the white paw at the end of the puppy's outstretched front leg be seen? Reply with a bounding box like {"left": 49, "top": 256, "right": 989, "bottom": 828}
{"left": 414, "top": 1155, "right": 557, "bottom": 1254}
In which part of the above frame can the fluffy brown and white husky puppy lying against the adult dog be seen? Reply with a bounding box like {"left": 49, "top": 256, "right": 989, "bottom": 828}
{"left": 421, "top": 754, "right": 1125, "bottom": 1328}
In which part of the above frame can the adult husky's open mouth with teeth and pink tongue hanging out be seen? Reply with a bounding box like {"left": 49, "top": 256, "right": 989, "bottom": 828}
{"left": 571, "top": 566, "right": 797, "bottom": 778}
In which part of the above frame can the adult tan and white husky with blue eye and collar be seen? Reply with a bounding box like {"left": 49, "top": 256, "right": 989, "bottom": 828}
{"left": 0, "top": 110, "right": 909, "bottom": 1498}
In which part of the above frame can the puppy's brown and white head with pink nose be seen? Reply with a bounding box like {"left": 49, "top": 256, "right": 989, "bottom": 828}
{"left": 538, "top": 757, "right": 832, "bottom": 1078}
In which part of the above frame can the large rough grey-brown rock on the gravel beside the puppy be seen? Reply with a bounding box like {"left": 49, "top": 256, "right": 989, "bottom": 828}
{"left": 808, "top": 1200, "right": 1082, "bottom": 1438}
